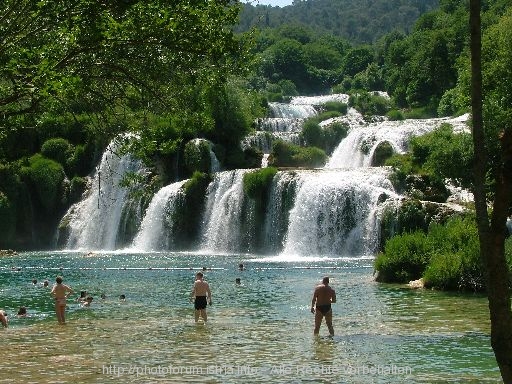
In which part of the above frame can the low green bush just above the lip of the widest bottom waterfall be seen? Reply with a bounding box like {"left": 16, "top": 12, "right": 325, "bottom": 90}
{"left": 269, "top": 140, "right": 327, "bottom": 168}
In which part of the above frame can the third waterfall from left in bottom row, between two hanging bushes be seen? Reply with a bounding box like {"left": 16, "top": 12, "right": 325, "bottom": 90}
{"left": 200, "top": 169, "right": 254, "bottom": 252}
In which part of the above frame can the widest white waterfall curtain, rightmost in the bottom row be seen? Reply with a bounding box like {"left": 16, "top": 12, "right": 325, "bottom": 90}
{"left": 282, "top": 168, "right": 398, "bottom": 255}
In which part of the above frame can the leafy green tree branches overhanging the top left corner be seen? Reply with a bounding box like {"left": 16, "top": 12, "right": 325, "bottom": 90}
{"left": 0, "top": 0, "right": 248, "bottom": 136}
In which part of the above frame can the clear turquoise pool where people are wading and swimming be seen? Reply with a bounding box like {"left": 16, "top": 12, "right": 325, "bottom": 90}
{"left": 0, "top": 252, "right": 500, "bottom": 383}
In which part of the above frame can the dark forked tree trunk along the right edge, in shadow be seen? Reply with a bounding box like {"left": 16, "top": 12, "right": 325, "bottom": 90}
{"left": 470, "top": 0, "right": 512, "bottom": 383}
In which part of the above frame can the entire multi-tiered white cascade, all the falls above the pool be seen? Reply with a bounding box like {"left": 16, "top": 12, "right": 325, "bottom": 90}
{"left": 59, "top": 95, "right": 467, "bottom": 258}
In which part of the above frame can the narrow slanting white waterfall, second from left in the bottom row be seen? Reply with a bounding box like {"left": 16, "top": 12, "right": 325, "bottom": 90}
{"left": 132, "top": 180, "right": 186, "bottom": 251}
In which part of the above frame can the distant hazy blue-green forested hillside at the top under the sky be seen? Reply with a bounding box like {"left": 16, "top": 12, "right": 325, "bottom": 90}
{"left": 236, "top": 0, "right": 439, "bottom": 44}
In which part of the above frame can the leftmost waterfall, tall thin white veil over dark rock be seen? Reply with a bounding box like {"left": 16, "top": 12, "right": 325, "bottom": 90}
{"left": 63, "top": 141, "right": 142, "bottom": 250}
